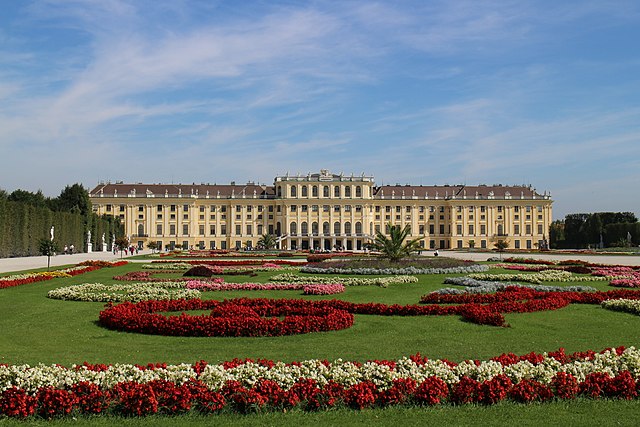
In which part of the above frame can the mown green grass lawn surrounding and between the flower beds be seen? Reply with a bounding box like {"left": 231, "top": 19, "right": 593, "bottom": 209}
{"left": 0, "top": 264, "right": 640, "bottom": 425}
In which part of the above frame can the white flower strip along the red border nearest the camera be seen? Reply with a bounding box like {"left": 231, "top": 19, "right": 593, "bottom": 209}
{"left": 0, "top": 347, "right": 640, "bottom": 393}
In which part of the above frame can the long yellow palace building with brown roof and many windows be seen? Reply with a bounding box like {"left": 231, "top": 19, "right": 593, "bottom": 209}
{"left": 90, "top": 170, "right": 553, "bottom": 250}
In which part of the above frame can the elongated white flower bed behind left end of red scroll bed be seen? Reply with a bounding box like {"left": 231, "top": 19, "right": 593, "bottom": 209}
{"left": 47, "top": 282, "right": 201, "bottom": 302}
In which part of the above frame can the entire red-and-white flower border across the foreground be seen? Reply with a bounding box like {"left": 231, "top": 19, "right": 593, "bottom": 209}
{"left": 0, "top": 347, "right": 640, "bottom": 418}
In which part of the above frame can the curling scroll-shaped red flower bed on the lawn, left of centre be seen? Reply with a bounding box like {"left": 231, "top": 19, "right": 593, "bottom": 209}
{"left": 99, "top": 299, "right": 353, "bottom": 337}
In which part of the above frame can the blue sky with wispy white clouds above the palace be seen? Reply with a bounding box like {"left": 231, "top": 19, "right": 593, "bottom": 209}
{"left": 0, "top": 0, "right": 640, "bottom": 219}
